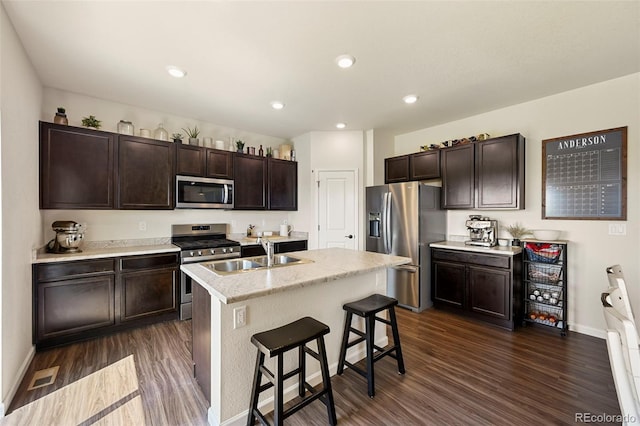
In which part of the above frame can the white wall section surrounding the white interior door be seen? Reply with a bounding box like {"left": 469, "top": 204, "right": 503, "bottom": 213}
{"left": 291, "top": 130, "right": 365, "bottom": 249}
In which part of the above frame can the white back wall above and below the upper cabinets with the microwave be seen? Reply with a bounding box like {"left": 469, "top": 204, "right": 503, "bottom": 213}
{"left": 41, "top": 88, "right": 296, "bottom": 245}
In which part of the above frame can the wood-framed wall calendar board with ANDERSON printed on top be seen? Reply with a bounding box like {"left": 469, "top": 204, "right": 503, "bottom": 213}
{"left": 542, "top": 127, "right": 627, "bottom": 220}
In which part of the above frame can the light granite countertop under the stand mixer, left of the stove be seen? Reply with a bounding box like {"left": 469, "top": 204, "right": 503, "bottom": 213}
{"left": 32, "top": 238, "right": 180, "bottom": 263}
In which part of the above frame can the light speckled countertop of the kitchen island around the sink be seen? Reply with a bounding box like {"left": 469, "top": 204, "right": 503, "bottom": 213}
{"left": 180, "top": 248, "right": 411, "bottom": 304}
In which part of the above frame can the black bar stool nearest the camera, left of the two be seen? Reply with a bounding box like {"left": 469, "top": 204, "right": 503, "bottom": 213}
{"left": 247, "top": 317, "right": 338, "bottom": 425}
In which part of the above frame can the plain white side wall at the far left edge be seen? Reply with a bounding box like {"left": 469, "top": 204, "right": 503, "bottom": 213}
{"left": 0, "top": 5, "right": 42, "bottom": 416}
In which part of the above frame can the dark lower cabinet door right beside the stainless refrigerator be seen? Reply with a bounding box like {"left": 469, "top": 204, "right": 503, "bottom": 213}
{"left": 432, "top": 262, "right": 466, "bottom": 308}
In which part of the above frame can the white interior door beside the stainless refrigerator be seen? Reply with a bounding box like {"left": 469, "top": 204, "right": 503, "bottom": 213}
{"left": 318, "top": 170, "right": 358, "bottom": 249}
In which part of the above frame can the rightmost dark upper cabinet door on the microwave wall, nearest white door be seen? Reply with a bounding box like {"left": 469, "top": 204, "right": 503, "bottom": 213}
{"left": 268, "top": 158, "right": 298, "bottom": 210}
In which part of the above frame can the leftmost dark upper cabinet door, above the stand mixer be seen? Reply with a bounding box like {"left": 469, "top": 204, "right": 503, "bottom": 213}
{"left": 40, "top": 122, "right": 116, "bottom": 209}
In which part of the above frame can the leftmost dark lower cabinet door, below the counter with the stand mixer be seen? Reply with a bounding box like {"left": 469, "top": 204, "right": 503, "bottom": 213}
{"left": 35, "top": 274, "right": 115, "bottom": 342}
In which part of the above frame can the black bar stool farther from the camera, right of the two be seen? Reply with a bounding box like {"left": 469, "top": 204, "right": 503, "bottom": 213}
{"left": 338, "top": 294, "right": 405, "bottom": 398}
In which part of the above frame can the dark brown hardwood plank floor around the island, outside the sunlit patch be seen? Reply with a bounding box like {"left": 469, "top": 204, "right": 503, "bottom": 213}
{"left": 11, "top": 309, "right": 620, "bottom": 425}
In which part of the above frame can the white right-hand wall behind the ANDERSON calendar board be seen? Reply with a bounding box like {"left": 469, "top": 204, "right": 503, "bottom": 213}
{"left": 395, "top": 74, "right": 640, "bottom": 336}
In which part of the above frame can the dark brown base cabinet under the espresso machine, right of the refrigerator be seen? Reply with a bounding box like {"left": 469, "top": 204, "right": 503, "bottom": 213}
{"left": 431, "top": 248, "right": 522, "bottom": 330}
